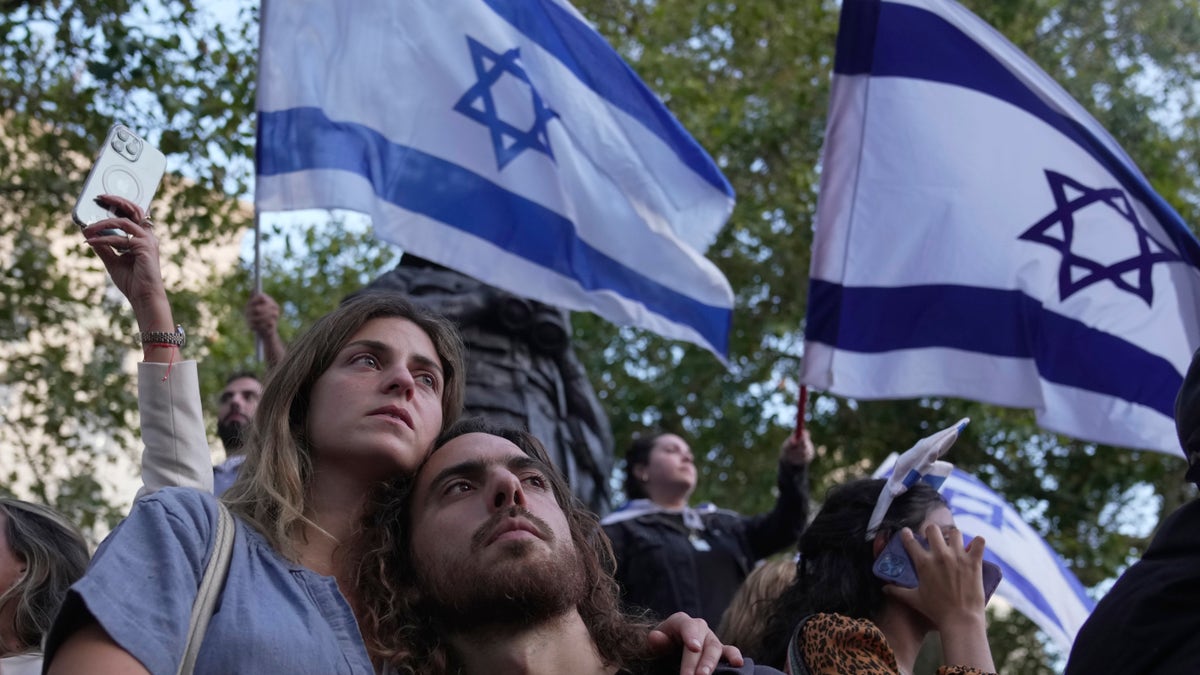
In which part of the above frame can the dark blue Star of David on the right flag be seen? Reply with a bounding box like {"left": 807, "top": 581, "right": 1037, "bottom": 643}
{"left": 1018, "top": 169, "right": 1182, "bottom": 305}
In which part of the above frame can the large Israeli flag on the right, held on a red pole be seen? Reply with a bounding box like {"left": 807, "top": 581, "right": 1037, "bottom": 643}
{"left": 803, "top": 0, "right": 1200, "bottom": 454}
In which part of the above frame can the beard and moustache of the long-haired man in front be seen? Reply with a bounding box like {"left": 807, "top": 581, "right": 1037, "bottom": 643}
{"left": 416, "top": 507, "right": 587, "bottom": 633}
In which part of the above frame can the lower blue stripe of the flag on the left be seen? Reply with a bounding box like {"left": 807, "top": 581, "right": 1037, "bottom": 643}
{"left": 258, "top": 108, "right": 732, "bottom": 354}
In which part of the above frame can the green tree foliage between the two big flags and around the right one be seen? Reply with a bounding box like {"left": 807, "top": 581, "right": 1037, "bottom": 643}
{"left": 574, "top": 0, "right": 1200, "bottom": 673}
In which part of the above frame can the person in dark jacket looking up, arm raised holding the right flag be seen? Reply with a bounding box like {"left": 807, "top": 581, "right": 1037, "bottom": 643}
{"left": 602, "top": 431, "right": 814, "bottom": 626}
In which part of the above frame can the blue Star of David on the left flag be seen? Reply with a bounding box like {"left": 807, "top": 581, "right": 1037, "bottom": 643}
{"left": 454, "top": 36, "right": 558, "bottom": 169}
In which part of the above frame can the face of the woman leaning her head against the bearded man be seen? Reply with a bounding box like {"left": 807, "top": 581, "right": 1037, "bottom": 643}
{"left": 307, "top": 317, "right": 445, "bottom": 482}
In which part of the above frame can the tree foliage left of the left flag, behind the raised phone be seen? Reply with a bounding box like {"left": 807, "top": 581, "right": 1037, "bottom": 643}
{"left": 0, "top": 0, "right": 257, "bottom": 531}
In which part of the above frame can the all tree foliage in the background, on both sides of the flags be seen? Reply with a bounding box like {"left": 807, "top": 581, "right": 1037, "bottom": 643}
{"left": 0, "top": 0, "right": 1200, "bottom": 673}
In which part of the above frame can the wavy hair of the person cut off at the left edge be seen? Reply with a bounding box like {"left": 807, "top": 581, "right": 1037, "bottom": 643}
{"left": 0, "top": 497, "right": 89, "bottom": 656}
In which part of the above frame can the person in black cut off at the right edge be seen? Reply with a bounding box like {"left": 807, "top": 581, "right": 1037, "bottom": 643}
{"left": 1067, "top": 351, "right": 1200, "bottom": 675}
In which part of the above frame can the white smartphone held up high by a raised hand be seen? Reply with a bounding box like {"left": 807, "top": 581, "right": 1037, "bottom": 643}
{"left": 71, "top": 124, "right": 167, "bottom": 229}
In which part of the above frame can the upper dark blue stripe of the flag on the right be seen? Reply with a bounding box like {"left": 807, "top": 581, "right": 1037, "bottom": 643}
{"left": 834, "top": 0, "right": 1200, "bottom": 267}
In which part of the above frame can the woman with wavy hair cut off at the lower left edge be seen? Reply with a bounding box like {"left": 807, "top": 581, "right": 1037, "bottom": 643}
{"left": 0, "top": 497, "right": 88, "bottom": 675}
